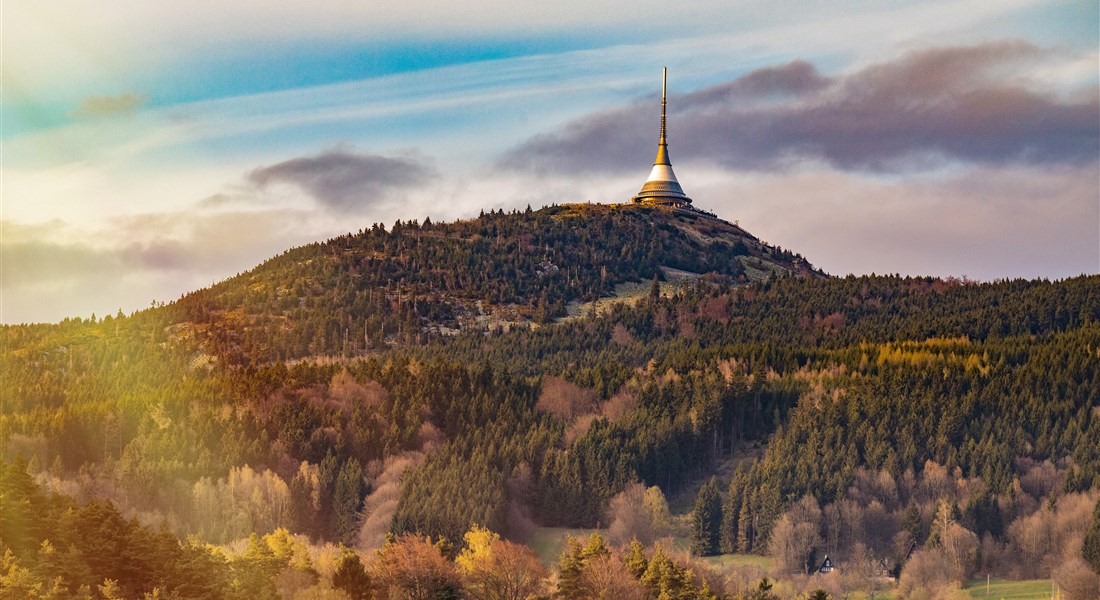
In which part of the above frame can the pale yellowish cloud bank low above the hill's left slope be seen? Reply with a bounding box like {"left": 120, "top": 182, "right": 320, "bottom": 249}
{"left": 0, "top": 208, "right": 336, "bottom": 323}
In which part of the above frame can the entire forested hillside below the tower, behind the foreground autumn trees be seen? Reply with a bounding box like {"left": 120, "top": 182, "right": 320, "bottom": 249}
{"left": 0, "top": 205, "right": 1100, "bottom": 597}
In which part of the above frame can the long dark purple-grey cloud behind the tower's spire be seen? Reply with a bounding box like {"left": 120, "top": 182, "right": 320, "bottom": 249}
{"left": 501, "top": 41, "right": 1100, "bottom": 173}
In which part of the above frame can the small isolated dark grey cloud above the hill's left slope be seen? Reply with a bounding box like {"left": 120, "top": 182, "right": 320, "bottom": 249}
{"left": 248, "top": 149, "right": 437, "bottom": 211}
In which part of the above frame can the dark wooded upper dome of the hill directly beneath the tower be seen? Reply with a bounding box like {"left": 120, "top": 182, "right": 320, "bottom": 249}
{"left": 162, "top": 205, "right": 821, "bottom": 364}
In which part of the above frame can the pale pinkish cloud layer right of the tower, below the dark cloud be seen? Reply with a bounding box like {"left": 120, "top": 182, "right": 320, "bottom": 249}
{"left": 691, "top": 162, "right": 1100, "bottom": 281}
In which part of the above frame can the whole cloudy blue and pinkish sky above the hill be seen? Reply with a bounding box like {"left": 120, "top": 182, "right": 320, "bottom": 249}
{"left": 0, "top": 0, "right": 1100, "bottom": 324}
